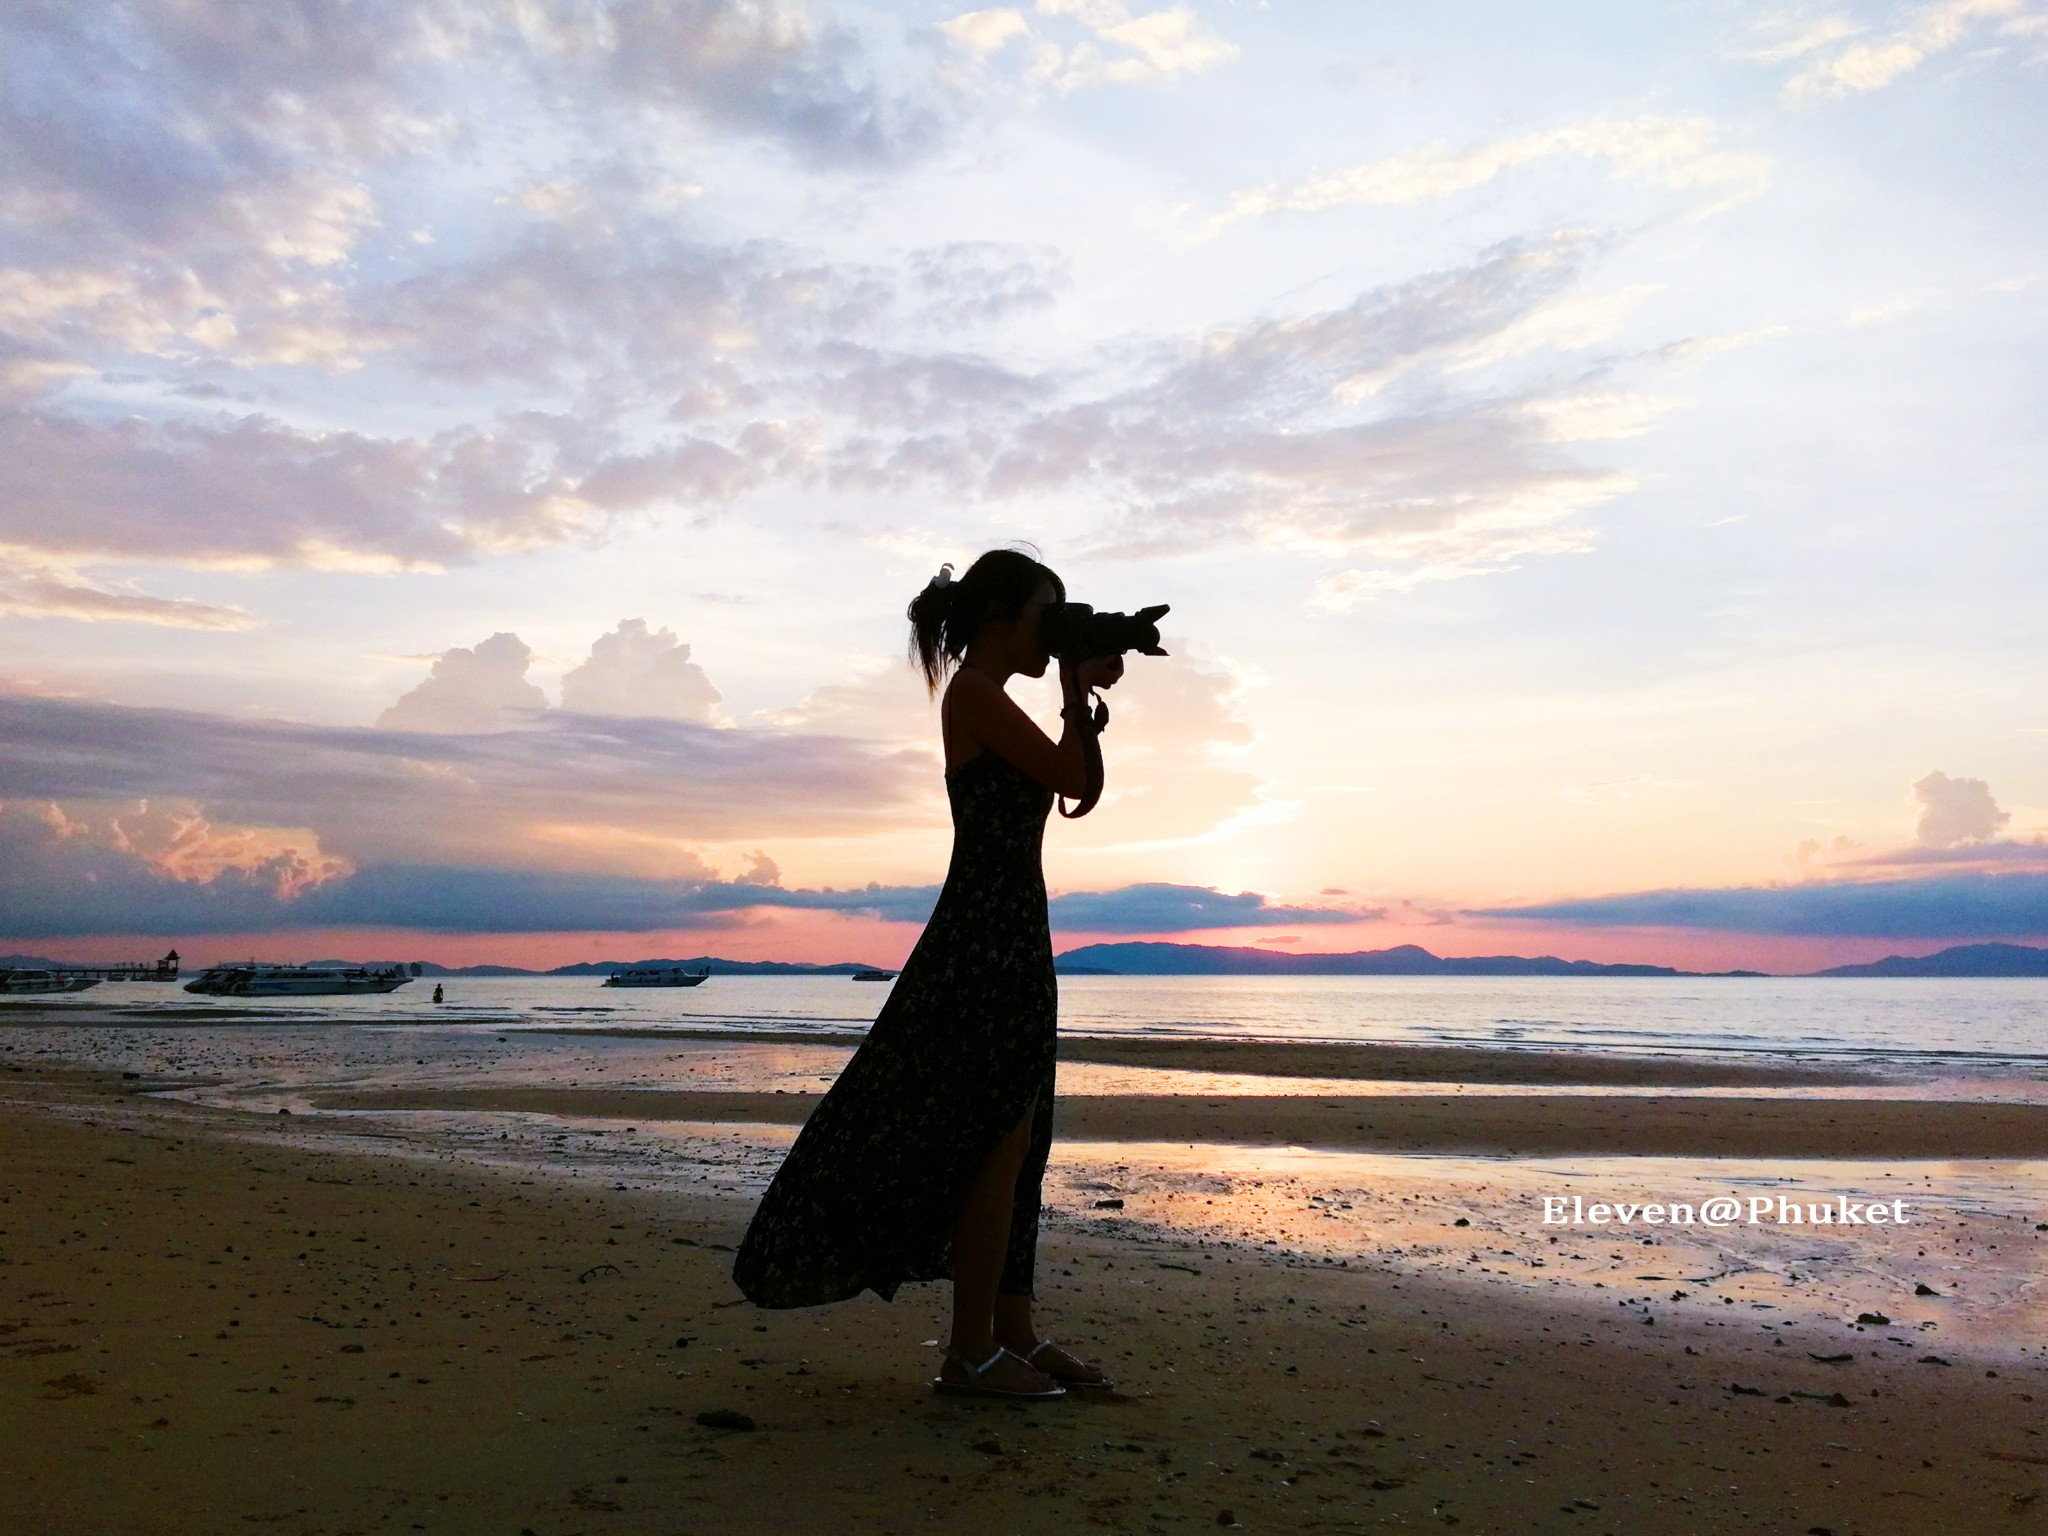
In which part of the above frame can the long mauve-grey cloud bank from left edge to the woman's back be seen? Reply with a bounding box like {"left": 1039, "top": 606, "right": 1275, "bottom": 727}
{"left": 0, "top": 696, "right": 936, "bottom": 877}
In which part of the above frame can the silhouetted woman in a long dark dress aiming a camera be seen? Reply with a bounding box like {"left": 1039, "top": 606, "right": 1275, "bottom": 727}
{"left": 733, "top": 549, "right": 1124, "bottom": 1397}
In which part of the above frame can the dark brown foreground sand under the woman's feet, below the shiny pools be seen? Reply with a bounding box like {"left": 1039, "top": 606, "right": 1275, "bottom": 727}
{"left": 0, "top": 1067, "right": 2048, "bottom": 1536}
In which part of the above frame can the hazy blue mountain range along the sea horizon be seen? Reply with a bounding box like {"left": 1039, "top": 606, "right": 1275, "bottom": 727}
{"left": 16, "top": 942, "right": 2048, "bottom": 979}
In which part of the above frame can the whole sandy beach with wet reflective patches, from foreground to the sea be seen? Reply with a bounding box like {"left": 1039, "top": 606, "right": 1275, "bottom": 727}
{"left": 0, "top": 1003, "right": 2048, "bottom": 1536}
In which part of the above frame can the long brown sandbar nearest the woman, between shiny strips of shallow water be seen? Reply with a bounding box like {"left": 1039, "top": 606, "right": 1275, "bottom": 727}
{"left": 309, "top": 1087, "right": 2048, "bottom": 1159}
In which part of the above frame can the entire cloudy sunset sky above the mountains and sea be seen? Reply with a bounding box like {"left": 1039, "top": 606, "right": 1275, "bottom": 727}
{"left": 0, "top": 0, "right": 2048, "bottom": 971}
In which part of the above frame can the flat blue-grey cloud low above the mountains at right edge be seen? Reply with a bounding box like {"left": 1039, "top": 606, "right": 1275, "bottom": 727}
{"left": 1466, "top": 872, "right": 2048, "bottom": 940}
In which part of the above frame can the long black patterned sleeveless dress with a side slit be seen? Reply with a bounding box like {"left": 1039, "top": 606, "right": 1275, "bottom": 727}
{"left": 733, "top": 750, "right": 1059, "bottom": 1307}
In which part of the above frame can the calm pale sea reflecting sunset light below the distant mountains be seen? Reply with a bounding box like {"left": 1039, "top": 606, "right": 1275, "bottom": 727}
{"left": 39, "top": 977, "right": 2048, "bottom": 1061}
